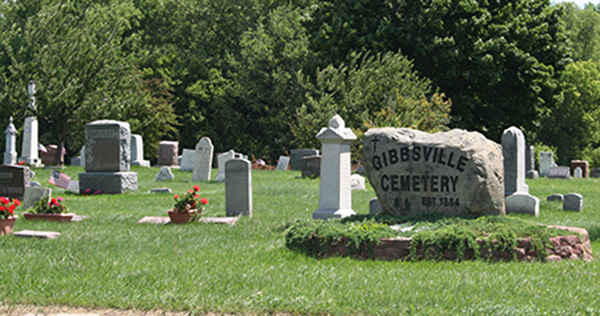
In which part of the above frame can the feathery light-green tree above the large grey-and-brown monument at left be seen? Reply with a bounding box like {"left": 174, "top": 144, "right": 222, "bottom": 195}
{"left": 3, "top": 1, "right": 174, "bottom": 163}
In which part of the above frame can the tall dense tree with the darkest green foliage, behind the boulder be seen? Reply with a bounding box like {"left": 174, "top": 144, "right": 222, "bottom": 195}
{"left": 308, "top": 0, "right": 568, "bottom": 140}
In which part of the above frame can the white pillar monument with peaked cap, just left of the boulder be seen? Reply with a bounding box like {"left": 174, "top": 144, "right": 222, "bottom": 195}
{"left": 312, "top": 115, "right": 356, "bottom": 219}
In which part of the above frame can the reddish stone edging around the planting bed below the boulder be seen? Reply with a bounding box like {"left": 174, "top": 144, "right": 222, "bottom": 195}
{"left": 323, "top": 226, "right": 593, "bottom": 261}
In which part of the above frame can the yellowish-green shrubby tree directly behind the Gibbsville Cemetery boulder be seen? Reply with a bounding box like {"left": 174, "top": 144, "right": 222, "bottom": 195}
{"left": 292, "top": 53, "right": 450, "bottom": 152}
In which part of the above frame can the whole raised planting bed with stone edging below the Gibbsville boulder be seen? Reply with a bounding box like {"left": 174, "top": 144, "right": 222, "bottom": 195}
{"left": 286, "top": 214, "right": 593, "bottom": 261}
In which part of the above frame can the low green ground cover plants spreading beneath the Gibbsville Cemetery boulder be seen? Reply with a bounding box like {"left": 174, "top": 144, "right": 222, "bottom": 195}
{"left": 285, "top": 213, "right": 583, "bottom": 260}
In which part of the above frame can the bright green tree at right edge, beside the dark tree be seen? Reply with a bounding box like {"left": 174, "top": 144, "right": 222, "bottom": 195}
{"left": 537, "top": 61, "right": 600, "bottom": 164}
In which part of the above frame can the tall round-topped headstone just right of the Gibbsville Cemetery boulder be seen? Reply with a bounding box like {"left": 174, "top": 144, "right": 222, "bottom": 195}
{"left": 502, "top": 126, "right": 529, "bottom": 195}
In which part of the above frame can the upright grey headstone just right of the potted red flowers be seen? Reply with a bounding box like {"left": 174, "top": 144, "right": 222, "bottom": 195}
{"left": 225, "top": 159, "right": 252, "bottom": 216}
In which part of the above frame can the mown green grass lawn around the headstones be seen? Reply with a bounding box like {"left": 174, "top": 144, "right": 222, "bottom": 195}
{"left": 0, "top": 167, "right": 600, "bottom": 315}
